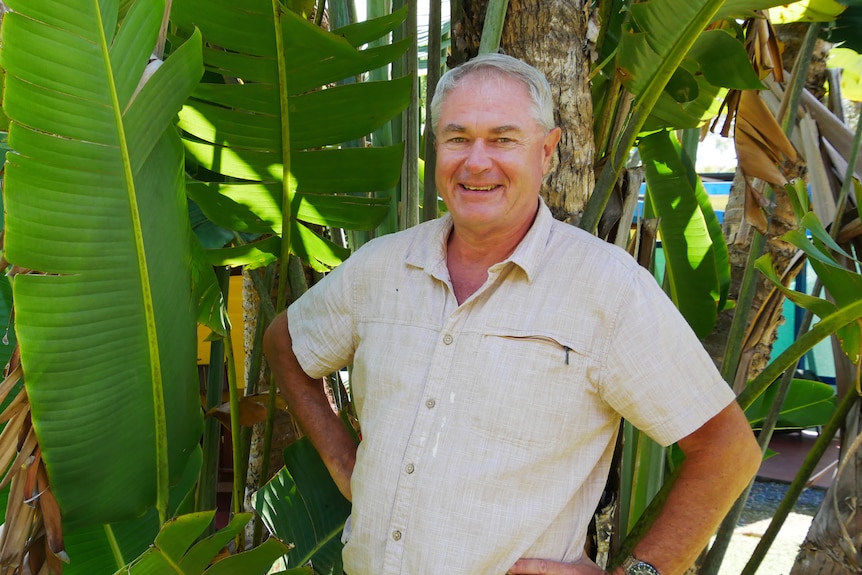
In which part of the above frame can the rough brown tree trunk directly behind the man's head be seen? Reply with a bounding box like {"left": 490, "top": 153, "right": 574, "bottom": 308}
{"left": 452, "top": 0, "right": 595, "bottom": 223}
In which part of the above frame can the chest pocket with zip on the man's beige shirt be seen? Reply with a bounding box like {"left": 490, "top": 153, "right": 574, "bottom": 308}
{"left": 469, "top": 330, "right": 585, "bottom": 451}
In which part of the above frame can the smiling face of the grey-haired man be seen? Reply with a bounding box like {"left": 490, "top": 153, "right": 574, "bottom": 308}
{"left": 436, "top": 72, "right": 560, "bottom": 235}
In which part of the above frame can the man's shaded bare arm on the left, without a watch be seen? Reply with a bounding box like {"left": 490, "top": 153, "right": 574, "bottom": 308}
{"left": 263, "top": 312, "right": 356, "bottom": 500}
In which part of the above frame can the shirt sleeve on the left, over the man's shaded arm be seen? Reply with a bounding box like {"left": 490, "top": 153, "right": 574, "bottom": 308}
{"left": 287, "top": 254, "right": 357, "bottom": 378}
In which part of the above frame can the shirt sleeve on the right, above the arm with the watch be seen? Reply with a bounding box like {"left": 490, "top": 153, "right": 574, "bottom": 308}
{"left": 603, "top": 268, "right": 735, "bottom": 446}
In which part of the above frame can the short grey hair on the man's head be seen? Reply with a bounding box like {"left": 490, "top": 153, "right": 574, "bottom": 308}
{"left": 431, "top": 54, "right": 556, "bottom": 134}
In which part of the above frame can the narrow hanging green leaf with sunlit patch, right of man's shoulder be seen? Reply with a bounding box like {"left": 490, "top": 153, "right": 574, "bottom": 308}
{"left": 638, "top": 131, "right": 730, "bottom": 337}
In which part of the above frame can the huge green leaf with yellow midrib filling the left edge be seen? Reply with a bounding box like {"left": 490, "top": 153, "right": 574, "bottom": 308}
{"left": 2, "top": 0, "right": 202, "bottom": 529}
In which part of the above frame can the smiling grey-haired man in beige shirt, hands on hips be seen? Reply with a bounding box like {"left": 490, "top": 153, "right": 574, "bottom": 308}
{"left": 265, "top": 55, "right": 760, "bottom": 575}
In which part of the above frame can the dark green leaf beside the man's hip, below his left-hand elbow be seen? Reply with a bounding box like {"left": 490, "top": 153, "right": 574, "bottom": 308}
{"left": 255, "top": 438, "right": 350, "bottom": 573}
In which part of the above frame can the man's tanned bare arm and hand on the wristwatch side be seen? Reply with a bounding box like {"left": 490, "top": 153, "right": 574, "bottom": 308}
{"left": 509, "top": 401, "right": 761, "bottom": 575}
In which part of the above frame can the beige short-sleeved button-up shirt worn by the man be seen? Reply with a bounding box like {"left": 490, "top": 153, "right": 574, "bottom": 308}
{"left": 288, "top": 202, "right": 734, "bottom": 575}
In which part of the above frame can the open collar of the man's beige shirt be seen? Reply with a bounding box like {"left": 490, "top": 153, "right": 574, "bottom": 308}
{"left": 405, "top": 197, "right": 554, "bottom": 281}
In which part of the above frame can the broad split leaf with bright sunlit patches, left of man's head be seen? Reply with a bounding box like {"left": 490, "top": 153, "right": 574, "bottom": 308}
{"left": 171, "top": 0, "right": 411, "bottom": 271}
